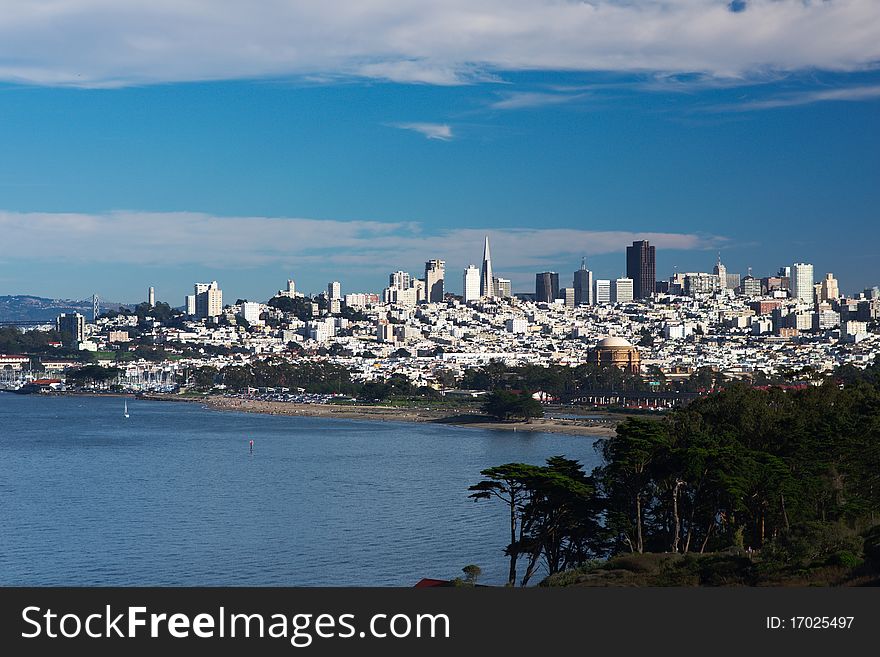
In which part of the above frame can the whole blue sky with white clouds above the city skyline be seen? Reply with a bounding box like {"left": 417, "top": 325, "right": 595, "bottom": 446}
{"left": 0, "top": 0, "right": 880, "bottom": 305}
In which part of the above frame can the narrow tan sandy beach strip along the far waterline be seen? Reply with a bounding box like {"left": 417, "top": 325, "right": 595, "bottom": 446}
{"left": 140, "top": 394, "right": 616, "bottom": 438}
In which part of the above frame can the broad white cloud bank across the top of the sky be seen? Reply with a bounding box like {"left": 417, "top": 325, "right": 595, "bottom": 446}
{"left": 0, "top": 0, "right": 880, "bottom": 86}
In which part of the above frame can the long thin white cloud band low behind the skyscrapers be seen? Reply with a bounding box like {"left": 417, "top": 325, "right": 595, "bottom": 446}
{"left": 0, "top": 211, "right": 725, "bottom": 274}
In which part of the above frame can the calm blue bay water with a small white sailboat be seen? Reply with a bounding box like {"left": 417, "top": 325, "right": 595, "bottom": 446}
{"left": 0, "top": 394, "right": 598, "bottom": 586}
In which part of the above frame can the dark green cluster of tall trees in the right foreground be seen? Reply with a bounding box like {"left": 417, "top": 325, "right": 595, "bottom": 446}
{"left": 470, "top": 364, "right": 880, "bottom": 584}
